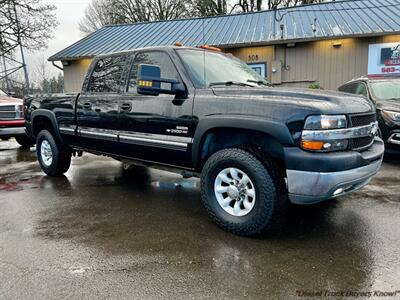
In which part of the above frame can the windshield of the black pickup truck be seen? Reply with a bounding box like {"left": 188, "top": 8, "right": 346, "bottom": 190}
{"left": 178, "top": 49, "right": 267, "bottom": 87}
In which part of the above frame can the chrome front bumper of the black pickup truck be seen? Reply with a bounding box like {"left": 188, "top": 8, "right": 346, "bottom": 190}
{"left": 287, "top": 138, "right": 385, "bottom": 204}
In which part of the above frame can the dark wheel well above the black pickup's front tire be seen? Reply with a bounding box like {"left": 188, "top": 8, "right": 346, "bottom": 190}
{"left": 197, "top": 128, "right": 286, "bottom": 173}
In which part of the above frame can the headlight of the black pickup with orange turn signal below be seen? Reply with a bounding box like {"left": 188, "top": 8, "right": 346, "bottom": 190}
{"left": 301, "top": 115, "right": 349, "bottom": 152}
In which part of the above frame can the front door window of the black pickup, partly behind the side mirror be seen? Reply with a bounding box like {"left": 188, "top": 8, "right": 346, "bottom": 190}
{"left": 128, "top": 51, "right": 180, "bottom": 93}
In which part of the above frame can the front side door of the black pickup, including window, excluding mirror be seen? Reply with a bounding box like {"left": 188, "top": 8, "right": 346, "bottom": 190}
{"left": 119, "top": 50, "right": 194, "bottom": 166}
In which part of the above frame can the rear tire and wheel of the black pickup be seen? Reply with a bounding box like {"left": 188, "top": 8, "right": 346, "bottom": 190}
{"left": 36, "top": 130, "right": 71, "bottom": 176}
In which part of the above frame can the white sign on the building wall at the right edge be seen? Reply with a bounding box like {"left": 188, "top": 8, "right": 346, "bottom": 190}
{"left": 368, "top": 42, "right": 400, "bottom": 76}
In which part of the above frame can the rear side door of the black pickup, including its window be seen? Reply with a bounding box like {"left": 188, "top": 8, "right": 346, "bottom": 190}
{"left": 77, "top": 55, "right": 127, "bottom": 153}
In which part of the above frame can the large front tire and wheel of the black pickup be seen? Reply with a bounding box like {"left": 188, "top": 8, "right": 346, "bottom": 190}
{"left": 201, "top": 148, "right": 285, "bottom": 236}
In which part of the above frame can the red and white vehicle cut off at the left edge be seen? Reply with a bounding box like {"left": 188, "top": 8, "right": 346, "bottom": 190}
{"left": 0, "top": 89, "right": 34, "bottom": 147}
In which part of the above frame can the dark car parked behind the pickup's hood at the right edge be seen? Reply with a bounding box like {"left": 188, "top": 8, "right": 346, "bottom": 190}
{"left": 338, "top": 77, "right": 400, "bottom": 154}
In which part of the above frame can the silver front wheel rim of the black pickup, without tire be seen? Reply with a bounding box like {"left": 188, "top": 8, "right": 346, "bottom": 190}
{"left": 214, "top": 168, "right": 256, "bottom": 217}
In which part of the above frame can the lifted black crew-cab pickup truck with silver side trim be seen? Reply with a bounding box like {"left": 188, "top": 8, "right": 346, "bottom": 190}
{"left": 24, "top": 46, "right": 384, "bottom": 235}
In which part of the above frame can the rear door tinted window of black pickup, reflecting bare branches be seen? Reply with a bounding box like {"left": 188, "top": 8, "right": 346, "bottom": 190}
{"left": 87, "top": 56, "right": 126, "bottom": 93}
